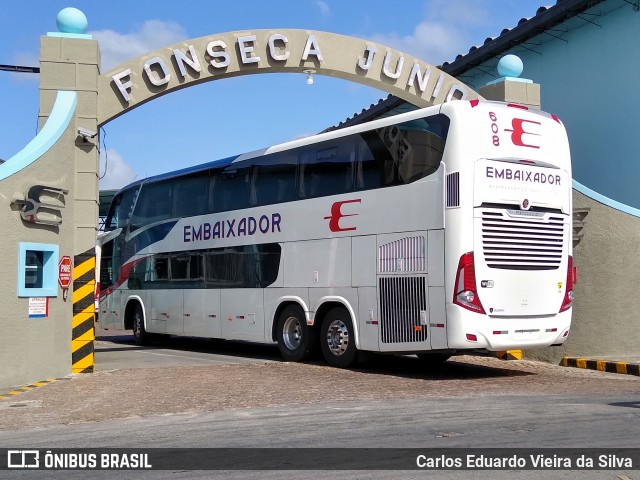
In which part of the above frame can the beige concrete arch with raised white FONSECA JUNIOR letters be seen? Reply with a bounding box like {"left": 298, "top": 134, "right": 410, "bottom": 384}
{"left": 97, "top": 29, "right": 480, "bottom": 125}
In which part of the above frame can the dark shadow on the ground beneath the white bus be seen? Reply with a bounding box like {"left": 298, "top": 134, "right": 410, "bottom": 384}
{"left": 96, "top": 334, "right": 535, "bottom": 380}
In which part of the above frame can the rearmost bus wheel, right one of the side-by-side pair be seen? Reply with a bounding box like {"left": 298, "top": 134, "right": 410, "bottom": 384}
{"left": 320, "top": 307, "right": 358, "bottom": 368}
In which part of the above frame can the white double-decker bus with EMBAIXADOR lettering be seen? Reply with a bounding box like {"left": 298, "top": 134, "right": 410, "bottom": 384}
{"left": 99, "top": 100, "right": 574, "bottom": 367}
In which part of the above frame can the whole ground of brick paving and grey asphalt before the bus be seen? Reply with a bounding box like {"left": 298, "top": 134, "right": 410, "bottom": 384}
{"left": 0, "top": 337, "right": 640, "bottom": 480}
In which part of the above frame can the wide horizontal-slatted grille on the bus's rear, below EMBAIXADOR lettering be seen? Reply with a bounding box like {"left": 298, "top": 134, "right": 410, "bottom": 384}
{"left": 482, "top": 211, "right": 566, "bottom": 270}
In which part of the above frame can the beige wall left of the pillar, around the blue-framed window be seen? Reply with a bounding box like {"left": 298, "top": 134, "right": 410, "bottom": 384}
{"left": 0, "top": 115, "right": 75, "bottom": 386}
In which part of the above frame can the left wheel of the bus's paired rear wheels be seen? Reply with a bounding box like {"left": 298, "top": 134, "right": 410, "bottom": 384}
{"left": 276, "top": 305, "right": 318, "bottom": 362}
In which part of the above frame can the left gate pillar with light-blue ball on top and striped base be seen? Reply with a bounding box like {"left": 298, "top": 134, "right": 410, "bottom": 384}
{"left": 39, "top": 9, "right": 100, "bottom": 373}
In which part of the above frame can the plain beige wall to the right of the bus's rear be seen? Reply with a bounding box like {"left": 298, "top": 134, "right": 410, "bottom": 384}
{"left": 525, "top": 190, "right": 640, "bottom": 363}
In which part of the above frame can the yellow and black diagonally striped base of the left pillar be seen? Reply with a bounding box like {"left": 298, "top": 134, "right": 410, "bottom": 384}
{"left": 71, "top": 249, "right": 96, "bottom": 373}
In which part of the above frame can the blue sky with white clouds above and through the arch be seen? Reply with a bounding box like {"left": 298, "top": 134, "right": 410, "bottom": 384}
{"left": 0, "top": 0, "right": 555, "bottom": 189}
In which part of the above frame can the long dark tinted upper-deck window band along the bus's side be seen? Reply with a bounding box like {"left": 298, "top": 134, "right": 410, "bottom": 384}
{"left": 107, "top": 115, "right": 449, "bottom": 225}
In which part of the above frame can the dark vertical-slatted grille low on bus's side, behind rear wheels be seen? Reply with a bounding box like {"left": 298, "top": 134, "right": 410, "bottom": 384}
{"left": 378, "top": 277, "right": 427, "bottom": 343}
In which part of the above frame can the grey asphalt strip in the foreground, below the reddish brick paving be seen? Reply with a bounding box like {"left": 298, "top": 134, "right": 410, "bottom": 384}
{"left": 0, "top": 395, "right": 640, "bottom": 479}
